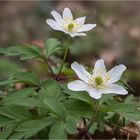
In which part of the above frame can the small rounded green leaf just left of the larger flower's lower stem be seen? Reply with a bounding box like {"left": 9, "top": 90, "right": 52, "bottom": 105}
{"left": 65, "top": 119, "right": 77, "bottom": 134}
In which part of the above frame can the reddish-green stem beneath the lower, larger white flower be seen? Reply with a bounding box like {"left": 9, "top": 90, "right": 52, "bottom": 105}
{"left": 86, "top": 100, "right": 100, "bottom": 132}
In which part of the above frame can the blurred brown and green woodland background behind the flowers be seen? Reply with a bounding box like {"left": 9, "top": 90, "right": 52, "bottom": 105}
{"left": 0, "top": 0, "right": 140, "bottom": 96}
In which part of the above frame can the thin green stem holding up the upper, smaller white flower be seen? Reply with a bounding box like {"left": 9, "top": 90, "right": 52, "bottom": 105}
{"left": 56, "top": 37, "right": 70, "bottom": 79}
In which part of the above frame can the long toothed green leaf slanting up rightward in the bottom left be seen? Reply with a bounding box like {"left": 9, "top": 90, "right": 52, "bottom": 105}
{"left": 15, "top": 117, "right": 55, "bottom": 138}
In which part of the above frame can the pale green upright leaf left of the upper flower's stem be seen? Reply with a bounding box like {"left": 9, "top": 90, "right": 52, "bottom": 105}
{"left": 45, "top": 38, "right": 62, "bottom": 57}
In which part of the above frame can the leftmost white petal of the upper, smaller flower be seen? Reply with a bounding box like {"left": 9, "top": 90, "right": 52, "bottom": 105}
{"left": 46, "top": 19, "right": 62, "bottom": 31}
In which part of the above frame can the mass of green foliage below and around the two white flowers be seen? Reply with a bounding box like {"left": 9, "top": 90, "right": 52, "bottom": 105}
{"left": 0, "top": 37, "right": 140, "bottom": 139}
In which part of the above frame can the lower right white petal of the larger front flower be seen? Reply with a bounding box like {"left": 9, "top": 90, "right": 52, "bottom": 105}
{"left": 103, "top": 84, "right": 128, "bottom": 95}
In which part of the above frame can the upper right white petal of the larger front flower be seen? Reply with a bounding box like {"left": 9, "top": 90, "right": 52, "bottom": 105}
{"left": 107, "top": 65, "right": 126, "bottom": 84}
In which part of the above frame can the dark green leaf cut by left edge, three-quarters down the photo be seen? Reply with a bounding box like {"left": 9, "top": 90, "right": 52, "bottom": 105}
{"left": 0, "top": 105, "right": 32, "bottom": 120}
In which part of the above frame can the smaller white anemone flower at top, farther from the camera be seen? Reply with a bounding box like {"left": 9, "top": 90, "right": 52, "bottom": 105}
{"left": 46, "top": 8, "right": 96, "bottom": 37}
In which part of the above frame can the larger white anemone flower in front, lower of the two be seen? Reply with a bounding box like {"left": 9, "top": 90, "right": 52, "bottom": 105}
{"left": 68, "top": 59, "right": 128, "bottom": 99}
